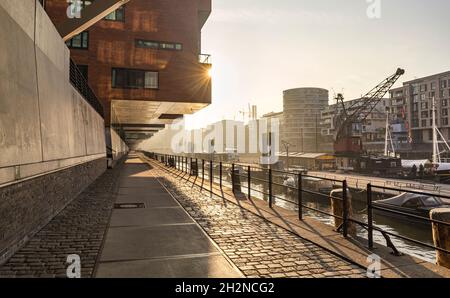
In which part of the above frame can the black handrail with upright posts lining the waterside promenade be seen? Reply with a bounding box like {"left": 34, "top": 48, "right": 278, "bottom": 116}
{"left": 146, "top": 153, "right": 450, "bottom": 255}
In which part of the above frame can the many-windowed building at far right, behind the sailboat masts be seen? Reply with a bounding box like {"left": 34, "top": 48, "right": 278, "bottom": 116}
{"left": 388, "top": 71, "right": 450, "bottom": 157}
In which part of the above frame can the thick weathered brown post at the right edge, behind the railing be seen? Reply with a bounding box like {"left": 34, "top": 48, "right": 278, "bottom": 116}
{"left": 430, "top": 208, "right": 450, "bottom": 269}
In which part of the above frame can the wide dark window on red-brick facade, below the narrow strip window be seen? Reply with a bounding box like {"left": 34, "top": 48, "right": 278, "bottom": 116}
{"left": 112, "top": 68, "right": 159, "bottom": 89}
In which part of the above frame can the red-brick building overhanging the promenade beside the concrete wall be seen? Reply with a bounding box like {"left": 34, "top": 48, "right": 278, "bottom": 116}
{"left": 45, "top": 0, "right": 211, "bottom": 146}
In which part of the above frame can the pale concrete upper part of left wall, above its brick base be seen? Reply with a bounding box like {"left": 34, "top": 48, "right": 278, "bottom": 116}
{"left": 0, "top": 0, "right": 106, "bottom": 187}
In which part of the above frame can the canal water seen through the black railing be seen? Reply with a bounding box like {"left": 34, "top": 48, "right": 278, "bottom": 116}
{"left": 200, "top": 167, "right": 436, "bottom": 263}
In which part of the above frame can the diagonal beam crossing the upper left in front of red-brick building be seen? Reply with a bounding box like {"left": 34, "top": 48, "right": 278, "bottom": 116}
{"left": 56, "top": 0, "right": 130, "bottom": 41}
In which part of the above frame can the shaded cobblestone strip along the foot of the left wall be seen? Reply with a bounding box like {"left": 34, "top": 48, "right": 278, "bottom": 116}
{"left": 0, "top": 165, "right": 121, "bottom": 277}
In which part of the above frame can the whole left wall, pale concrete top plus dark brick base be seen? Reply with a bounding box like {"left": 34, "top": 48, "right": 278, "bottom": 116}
{"left": 0, "top": 0, "right": 106, "bottom": 263}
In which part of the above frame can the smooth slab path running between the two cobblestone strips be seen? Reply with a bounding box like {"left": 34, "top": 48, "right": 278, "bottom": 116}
{"left": 96, "top": 155, "right": 242, "bottom": 278}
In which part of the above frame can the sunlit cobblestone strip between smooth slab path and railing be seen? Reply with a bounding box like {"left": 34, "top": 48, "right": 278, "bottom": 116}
{"left": 149, "top": 162, "right": 366, "bottom": 278}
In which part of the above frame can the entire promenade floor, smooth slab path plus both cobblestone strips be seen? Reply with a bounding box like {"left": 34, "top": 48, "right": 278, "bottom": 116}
{"left": 0, "top": 156, "right": 366, "bottom": 277}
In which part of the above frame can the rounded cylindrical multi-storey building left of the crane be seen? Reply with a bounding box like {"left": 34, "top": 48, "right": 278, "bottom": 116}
{"left": 281, "top": 88, "right": 328, "bottom": 152}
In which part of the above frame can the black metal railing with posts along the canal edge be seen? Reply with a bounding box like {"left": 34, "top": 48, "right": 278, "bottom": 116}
{"left": 142, "top": 152, "right": 450, "bottom": 256}
